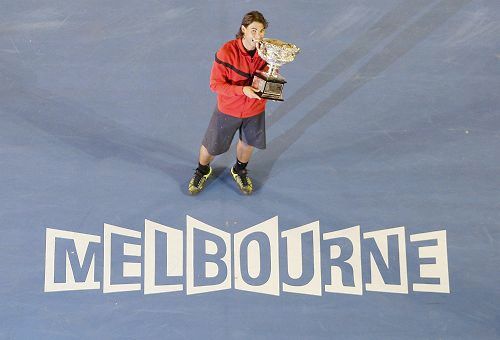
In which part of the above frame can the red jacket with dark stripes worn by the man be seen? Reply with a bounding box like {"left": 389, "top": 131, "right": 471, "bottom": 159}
{"left": 210, "top": 39, "right": 267, "bottom": 118}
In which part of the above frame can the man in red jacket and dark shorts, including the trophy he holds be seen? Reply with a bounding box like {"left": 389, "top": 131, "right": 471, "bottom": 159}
{"left": 188, "top": 11, "right": 299, "bottom": 195}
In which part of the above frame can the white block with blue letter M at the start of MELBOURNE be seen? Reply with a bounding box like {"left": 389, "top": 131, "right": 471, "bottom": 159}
{"left": 44, "top": 228, "right": 101, "bottom": 292}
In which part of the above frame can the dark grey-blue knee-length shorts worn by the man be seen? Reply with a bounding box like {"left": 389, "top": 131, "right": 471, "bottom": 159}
{"left": 202, "top": 108, "right": 266, "bottom": 156}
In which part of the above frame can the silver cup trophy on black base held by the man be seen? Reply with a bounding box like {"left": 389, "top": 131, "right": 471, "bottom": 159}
{"left": 252, "top": 38, "right": 300, "bottom": 101}
